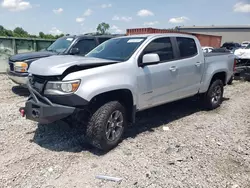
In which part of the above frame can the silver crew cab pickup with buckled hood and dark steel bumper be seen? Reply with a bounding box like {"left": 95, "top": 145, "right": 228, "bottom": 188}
{"left": 20, "top": 33, "right": 235, "bottom": 151}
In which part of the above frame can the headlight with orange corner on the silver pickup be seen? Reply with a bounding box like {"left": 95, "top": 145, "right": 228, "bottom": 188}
{"left": 44, "top": 80, "right": 81, "bottom": 95}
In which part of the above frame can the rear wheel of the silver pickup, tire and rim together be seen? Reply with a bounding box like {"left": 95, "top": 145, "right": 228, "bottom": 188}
{"left": 204, "top": 80, "right": 224, "bottom": 110}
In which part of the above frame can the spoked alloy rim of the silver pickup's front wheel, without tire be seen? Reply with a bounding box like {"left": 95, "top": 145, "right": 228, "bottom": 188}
{"left": 105, "top": 110, "right": 123, "bottom": 142}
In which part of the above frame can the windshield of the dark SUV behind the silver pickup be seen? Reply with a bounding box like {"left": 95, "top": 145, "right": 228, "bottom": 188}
{"left": 47, "top": 37, "right": 74, "bottom": 53}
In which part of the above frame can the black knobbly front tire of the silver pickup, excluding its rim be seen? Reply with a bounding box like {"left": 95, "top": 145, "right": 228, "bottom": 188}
{"left": 85, "top": 101, "right": 127, "bottom": 151}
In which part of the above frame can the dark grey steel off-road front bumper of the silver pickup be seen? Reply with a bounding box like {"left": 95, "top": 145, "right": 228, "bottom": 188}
{"left": 20, "top": 83, "right": 75, "bottom": 124}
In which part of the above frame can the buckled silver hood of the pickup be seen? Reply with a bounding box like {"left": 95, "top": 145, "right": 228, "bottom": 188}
{"left": 28, "top": 55, "right": 117, "bottom": 76}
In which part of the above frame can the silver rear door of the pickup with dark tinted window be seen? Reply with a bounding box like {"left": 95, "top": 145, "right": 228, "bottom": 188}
{"left": 175, "top": 37, "right": 204, "bottom": 98}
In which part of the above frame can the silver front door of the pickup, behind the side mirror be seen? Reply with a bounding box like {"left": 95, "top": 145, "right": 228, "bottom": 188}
{"left": 137, "top": 37, "right": 178, "bottom": 110}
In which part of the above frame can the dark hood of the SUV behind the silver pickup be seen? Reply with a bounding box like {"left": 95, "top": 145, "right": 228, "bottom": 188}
{"left": 10, "top": 51, "right": 56, "bottom": 62}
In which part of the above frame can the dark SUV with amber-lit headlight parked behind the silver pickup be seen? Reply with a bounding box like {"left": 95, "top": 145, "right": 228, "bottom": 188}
{"left": 7, "top": 34, "right": 115, "bottom": 87}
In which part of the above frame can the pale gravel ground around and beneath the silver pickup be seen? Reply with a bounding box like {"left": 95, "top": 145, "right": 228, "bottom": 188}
{"left": 0, "top": 75, "right": 250, "bottom": 188}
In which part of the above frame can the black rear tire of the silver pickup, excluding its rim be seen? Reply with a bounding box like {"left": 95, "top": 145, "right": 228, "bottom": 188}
{"left": 203, "top": 79, "right": 224, "bottom": 110}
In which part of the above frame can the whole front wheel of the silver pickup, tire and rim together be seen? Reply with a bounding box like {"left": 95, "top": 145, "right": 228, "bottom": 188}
{"left": 86, "top": 101, "right": 127, "bottom": 151}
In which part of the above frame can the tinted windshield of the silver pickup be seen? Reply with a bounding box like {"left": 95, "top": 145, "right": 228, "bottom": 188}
{"left": 86, "top": 37, "right": 146, "bottom": 61}
